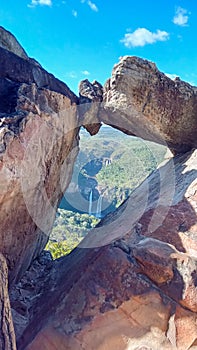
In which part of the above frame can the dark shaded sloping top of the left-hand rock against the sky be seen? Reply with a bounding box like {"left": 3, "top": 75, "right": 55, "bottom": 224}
{"left": 0, "top": 26, "right": 78, "bottom": 104}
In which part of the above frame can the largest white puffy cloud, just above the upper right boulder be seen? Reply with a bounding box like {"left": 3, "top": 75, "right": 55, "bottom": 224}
{"left": 121, "top": 28, "right": 169, "bottom": 48}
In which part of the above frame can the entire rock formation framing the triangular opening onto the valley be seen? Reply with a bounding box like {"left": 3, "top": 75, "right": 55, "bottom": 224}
{"left": 0, "top": 27, "right": 197, "bottom": 350}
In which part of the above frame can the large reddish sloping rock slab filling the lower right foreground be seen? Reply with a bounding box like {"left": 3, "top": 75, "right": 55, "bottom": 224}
{"left": 11, "top": 151, "right": 197, "bottom": 350}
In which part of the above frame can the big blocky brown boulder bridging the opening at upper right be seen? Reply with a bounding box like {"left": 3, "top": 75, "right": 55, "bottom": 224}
{"left": 100, "top": 56, "right": 197, "bottom": 152}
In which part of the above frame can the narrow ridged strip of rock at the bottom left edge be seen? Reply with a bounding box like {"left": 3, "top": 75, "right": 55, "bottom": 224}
{"left": 0, "top": 253, "right": 16, "bottom": 350}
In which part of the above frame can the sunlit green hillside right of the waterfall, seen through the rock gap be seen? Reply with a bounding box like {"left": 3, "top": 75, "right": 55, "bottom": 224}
{"left": 96, "top": 139, "right": 166, "bottom": 207}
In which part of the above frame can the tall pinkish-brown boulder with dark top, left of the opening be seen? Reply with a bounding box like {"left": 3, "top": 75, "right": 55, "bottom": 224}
{"left": 0, "top": 28, "right": 79, "bottom": 281}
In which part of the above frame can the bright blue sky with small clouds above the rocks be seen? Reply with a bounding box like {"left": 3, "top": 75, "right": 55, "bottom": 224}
{"left": 0, "top": 0, "right": 197, "bottom": 93}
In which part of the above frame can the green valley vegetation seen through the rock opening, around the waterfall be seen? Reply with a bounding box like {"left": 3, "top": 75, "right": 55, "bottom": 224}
{"left": 46, "top": 128, "right": 166, "bottom": 258}
